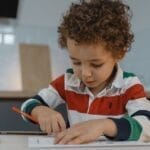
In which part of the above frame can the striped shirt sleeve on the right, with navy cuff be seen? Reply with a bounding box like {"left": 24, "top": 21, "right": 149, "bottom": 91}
{"left": 108, "top": 77, "right": 150, "bottom": 141}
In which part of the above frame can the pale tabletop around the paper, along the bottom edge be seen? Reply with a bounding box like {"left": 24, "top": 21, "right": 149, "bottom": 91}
{"left": 0, "top": 135, "right": 150, "bottom": 150}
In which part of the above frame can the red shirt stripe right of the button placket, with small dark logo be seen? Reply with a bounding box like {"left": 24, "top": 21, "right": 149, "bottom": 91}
{"left": 89, "top": 84, "right": 145, "bottom": 115}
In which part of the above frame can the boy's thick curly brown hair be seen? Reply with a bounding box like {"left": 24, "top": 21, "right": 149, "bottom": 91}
{"left": 58, "top": 0, "right": 134, "bottom": 57}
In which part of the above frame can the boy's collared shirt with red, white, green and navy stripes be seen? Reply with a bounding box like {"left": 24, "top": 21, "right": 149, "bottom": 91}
{"left": 21, "top": 65, "right": 150, "bottom": 141}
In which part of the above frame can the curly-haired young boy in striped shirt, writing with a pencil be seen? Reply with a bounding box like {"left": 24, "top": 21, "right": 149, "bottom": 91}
{"left": 22, "top": 0, "right": 150, "bottom": 144}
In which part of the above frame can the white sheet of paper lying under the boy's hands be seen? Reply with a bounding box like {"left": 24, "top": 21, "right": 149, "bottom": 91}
{"left": 28, "top": 136, "right": 150, "bottom": 148}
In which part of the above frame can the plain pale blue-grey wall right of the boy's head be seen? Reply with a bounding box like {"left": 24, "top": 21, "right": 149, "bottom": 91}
{"left": 122, "top": 0, "right": 150, "bottom": 91}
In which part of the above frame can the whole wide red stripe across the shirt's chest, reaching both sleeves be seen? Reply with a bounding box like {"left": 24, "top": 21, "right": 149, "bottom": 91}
{"left": 52, "top": 79, "right": 145, "bottom": 115}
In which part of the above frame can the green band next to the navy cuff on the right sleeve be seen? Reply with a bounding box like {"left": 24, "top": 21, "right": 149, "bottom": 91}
{"left": 124, "top": 116, "right": 142, "bottom": 141}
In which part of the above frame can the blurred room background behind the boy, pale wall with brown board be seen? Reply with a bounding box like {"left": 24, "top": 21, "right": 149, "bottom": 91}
{"left": 0, "top": 0, "right": 150, "bottom": 97}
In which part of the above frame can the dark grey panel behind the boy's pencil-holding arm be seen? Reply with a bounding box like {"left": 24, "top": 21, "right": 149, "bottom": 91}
{"left": 0, "top": 98, "right": 68, "bottom": 134}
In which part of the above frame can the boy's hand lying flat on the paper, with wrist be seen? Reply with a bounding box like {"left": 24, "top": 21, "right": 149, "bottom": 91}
{"left": 55, "top": 119, "right": 117, "bottom": 144}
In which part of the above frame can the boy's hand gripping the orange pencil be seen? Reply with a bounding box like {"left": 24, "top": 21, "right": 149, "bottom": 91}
{"left": 31, "top": 106, "right": 66, "bottom": 134}
